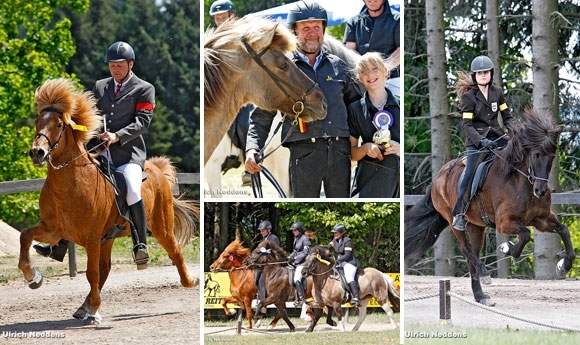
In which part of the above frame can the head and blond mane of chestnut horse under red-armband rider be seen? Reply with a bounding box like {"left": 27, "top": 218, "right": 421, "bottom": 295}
{"left": 28, "top": 78, "right": 101, "bottom": 166}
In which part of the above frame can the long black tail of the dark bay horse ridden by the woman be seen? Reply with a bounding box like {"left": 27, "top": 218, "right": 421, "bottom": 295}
{"left": 405, "top": 187, "right": 449, "bottom": 259}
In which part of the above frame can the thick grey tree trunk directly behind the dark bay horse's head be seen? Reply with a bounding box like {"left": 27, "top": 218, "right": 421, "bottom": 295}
{"left": 532, "top": 0, "right": 561, "bottom": 279}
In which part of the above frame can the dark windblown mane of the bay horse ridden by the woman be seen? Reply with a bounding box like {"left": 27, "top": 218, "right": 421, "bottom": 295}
{"left": 500, "top": 108, "right": 560, "bottom": 178}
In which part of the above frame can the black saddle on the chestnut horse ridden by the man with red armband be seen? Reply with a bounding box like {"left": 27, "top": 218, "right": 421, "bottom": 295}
{"left": 95, "top": 155, "right": 147, "bottom": 240}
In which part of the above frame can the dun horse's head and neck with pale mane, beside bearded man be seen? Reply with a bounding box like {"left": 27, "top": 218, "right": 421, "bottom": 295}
{"left": 204, "top": 17, "right": 326, "bottom": 164}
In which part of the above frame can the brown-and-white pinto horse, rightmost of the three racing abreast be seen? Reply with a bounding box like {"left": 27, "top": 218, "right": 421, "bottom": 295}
{"left": 302, "top": 245, "right": 400, "bottom": 332}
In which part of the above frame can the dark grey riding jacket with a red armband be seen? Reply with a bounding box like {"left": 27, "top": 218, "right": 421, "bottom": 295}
{"left": 93, "top": 74, "right": 155, "bottom": 168}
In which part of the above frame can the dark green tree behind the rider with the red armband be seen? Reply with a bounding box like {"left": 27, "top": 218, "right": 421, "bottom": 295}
{"left": 67, "top": 0, "right": 200, "bottom": 172}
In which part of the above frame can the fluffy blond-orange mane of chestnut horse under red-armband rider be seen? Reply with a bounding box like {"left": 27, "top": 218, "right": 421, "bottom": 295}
{"left": 34, "top": 78, "right": 102, "bottom": 143}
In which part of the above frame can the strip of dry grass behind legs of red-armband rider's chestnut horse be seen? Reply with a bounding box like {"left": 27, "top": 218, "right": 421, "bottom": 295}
{"left": 0, "top": 236, "right": 200, "bottom": 284}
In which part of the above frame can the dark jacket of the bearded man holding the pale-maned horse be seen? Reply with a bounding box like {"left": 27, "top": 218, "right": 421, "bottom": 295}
{"left": 246, "top": 49, "right": 362, "bottom": 151}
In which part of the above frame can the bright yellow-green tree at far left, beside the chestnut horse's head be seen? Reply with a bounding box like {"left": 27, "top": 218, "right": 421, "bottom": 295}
{"left": 0, "top": 0, "right": 89, "bottom": 226}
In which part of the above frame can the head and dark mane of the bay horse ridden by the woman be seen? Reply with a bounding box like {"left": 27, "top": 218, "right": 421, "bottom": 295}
{"left": 500, "top": 109, "right": 561, "bottom": 198}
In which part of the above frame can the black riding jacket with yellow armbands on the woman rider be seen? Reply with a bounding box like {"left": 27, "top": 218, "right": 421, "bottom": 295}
{"left": 461, "top": 84, "right": 515, "bottom": 148}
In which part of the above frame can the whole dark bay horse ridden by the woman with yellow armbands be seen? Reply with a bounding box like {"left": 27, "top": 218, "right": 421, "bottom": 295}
{"left": 405, "top": 109, "right": 576, "bottom": 305}
